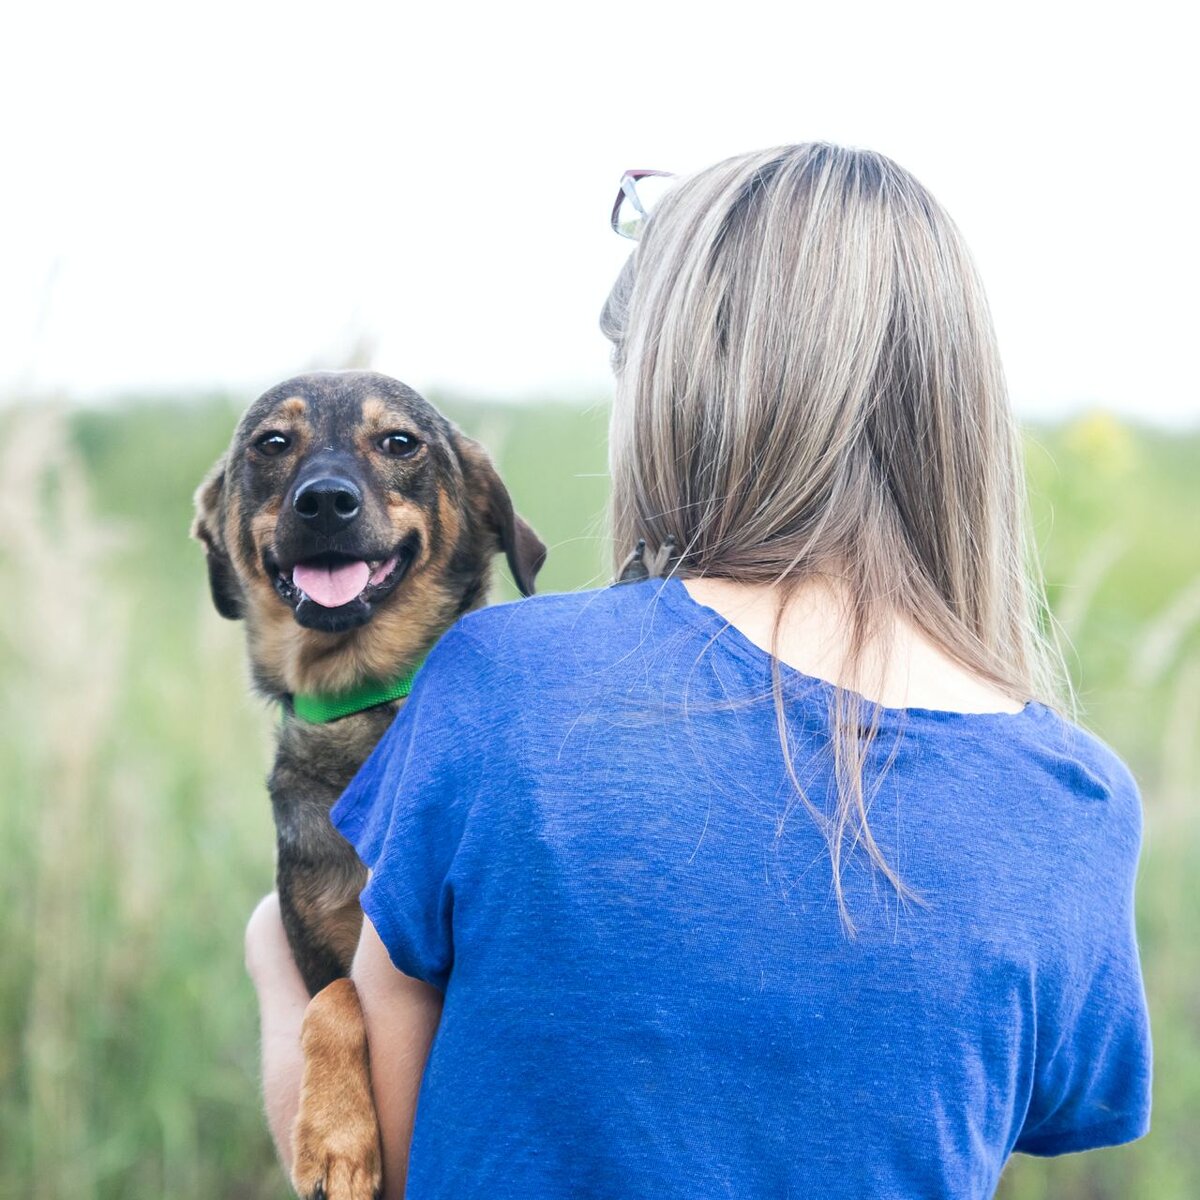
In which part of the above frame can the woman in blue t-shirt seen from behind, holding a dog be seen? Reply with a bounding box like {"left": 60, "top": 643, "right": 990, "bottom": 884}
{"left": 250, "top": 144, "right": 1150, "bottom": 1200}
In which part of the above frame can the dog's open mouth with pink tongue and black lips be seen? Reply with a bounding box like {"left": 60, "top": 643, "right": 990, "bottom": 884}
{"left": 265, "top": 538, "right": 416, "bottom": 632}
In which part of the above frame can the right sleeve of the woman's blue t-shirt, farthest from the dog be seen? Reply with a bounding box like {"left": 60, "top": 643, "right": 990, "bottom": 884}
{"left": 1015, "top": 779, "right": 1151, "bottom": 1156}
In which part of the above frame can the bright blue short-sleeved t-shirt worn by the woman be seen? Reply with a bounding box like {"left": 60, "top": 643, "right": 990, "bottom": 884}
{"left": 334, "top": 580, "right": 1151, "bottom": 1200}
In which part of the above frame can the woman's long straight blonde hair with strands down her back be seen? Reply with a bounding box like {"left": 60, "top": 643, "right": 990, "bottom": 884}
{"left": 601, "top": 143, "right": 1069, "bottom": 931}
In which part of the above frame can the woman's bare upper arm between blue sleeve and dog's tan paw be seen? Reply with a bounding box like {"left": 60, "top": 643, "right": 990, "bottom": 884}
{"left": 350, "top": 918, "right": 442, "bottom": 1200}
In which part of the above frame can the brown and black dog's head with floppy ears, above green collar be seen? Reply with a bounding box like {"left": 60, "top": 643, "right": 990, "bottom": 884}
{"left": 193, "top": 371, "right": 545, "bottom": 691}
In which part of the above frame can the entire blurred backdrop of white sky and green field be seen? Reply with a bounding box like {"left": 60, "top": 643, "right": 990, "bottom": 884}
{"left": 0, "top": 0, "right": 1200, "bottom": 1200}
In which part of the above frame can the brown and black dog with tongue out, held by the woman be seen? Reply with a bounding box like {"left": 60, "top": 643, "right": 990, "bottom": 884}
{"left": 192, "top": 371, "right": 546, "bottom": 1200}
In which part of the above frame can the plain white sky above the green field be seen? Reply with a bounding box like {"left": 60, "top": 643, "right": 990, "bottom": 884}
{"left": 0, "top": 0, "right": 1200, "bottom": 422}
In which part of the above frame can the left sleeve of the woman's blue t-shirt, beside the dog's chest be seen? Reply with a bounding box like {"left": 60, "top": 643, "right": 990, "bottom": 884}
{"left": 330, "top": 626, "right": 498, "bottom": 990}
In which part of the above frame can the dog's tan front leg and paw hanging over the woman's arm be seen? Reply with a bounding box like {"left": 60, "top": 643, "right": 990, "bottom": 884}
{"left": 292, "top": 979, "right": 383, "bottom": 1200}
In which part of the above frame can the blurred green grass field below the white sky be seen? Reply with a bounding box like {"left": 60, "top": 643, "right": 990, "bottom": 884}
{"left": 0, "top": 400, "right": 1200, "bottom": 1200}
